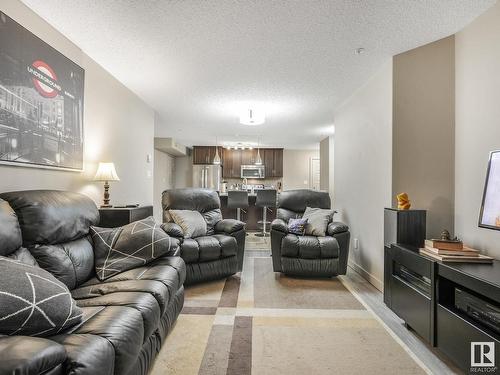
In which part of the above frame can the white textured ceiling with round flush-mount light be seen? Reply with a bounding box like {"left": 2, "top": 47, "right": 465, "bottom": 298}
{"left": 23, "top": 0, "right": 495, "bottom": 148}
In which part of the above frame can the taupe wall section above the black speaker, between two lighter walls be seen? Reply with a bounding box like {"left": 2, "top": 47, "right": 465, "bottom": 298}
{"left": 392, "top": 36, "right": 455, "bottom": 238}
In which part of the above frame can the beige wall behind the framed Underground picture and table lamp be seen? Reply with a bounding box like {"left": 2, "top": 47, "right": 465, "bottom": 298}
{"left": 0, "top": 0, "right": 154, "bottom": 204}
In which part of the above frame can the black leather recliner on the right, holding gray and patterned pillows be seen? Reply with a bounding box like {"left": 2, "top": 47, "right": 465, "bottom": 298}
{"left": 271, "top": 189, "right": 350, "bottom": 277}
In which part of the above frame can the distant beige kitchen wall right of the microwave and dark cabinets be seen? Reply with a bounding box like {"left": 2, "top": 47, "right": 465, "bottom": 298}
{"left": 283, "top": 149, "right": 319, "bottom": 190}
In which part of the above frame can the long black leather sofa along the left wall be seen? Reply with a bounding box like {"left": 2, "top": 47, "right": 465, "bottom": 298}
{"left": 0, "top": 191, "right": 186, "bottom": 375}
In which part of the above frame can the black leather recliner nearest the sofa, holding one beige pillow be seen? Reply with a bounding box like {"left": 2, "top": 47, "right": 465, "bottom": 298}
{"left": 162, "top": 188, "right": 246, "bottom": 285}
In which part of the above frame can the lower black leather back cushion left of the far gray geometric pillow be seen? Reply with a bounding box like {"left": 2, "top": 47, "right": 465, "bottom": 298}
{"left": 30, "top": 236, "right": 94, "bottom": 289}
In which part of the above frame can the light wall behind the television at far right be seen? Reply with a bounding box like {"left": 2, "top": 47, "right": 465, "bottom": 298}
{"left": 455, "top": 3, "right": 500, "bottom": 259}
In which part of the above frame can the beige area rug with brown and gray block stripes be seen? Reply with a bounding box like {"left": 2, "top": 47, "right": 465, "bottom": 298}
{"left": 151, "top": 236, "right": 425, "bottom": 375}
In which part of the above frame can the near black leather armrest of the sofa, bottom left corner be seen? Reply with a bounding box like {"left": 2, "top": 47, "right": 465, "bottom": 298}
{"left": 0, "top": 336, "right": 66, "bottom": 375}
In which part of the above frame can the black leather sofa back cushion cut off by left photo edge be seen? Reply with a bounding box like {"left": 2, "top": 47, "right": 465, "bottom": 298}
{"left": 0, "top": 199, "right": 23, "bottom": 256}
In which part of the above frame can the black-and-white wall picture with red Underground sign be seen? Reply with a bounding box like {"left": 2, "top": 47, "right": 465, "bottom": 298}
{"left": 0, "top": 12, "right": 85, "bottom": 170}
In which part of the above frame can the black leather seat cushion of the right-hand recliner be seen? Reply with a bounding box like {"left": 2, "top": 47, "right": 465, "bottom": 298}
{"left": 281, "top": 234, "right": 339, "bottom": 259}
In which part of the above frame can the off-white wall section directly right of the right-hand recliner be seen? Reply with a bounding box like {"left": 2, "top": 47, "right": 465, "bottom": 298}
{"left": 334, "top": 60, "right": 392, "bottom": 289}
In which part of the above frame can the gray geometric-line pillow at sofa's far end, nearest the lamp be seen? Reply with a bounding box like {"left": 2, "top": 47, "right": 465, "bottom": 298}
{"left": 90, "top": 216, "right": 176, "bottom": 281}
